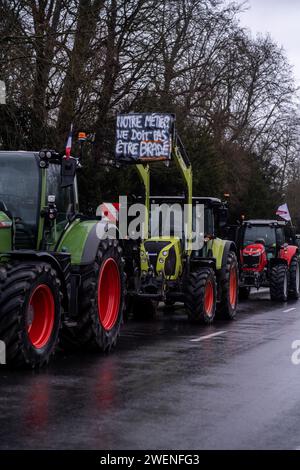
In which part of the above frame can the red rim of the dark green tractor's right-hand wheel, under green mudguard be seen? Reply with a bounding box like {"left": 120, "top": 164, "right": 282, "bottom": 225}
{"left": 98, "top": 258, "right": 121, "bottom": 330}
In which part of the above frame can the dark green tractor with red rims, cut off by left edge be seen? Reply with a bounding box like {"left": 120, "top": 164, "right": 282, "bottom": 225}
{"left": 0, "top": 141, "right": 124, "bottom": 367}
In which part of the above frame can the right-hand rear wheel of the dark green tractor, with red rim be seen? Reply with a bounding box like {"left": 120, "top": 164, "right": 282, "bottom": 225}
{"left": 61, "top": 240, "right": 125, "bottom": 352}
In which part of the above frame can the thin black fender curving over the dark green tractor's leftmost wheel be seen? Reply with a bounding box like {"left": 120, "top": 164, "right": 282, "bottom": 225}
{"left": 7, "top": 250, "right": 71, "bottom": 311}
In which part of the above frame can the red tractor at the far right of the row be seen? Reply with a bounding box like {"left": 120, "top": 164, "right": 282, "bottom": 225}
{"left": 238, "top": 220, "right": 300, "bottom": 302}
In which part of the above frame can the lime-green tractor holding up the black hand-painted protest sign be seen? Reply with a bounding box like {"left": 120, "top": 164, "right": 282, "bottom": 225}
{"left": 116, "top": 113, "right": 238, "bottom": 324}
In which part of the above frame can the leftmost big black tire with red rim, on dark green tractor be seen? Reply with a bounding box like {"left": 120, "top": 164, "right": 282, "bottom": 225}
{"left": 0, "top": 262, "right": 62, "bottom": 368}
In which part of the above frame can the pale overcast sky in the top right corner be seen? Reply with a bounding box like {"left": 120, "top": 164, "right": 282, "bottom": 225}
{"left": 240, "top": 0, "right": 300, "bottom": 85}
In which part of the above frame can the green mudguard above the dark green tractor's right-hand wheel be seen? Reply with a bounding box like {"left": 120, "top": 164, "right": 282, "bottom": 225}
{"left": 56, "top": 219, "right": 118, "bottom": 265}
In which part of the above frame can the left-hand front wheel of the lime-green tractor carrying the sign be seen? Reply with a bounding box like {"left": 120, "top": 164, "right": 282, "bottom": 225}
{"left": 185, "top": 268, "right": 217, "bottom": 324}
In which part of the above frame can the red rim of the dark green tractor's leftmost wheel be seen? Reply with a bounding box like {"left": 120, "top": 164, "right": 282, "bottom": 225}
{"left": 27, "top": 284, "right": 55, "bottom": 349}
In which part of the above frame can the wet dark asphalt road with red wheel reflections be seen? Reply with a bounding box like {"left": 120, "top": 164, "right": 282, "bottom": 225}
{"left": 0, "top": 293, "right": 300, "bottom": 450}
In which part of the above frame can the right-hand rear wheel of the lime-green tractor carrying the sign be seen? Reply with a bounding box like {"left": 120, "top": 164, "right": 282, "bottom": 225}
{"left": 217, "top": 251, "right": 239, "bottom": 320}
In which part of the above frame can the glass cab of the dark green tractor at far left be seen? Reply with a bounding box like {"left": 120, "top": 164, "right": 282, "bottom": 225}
{"left": 0, "top": 151, "right": 77, "bottom": 252}
